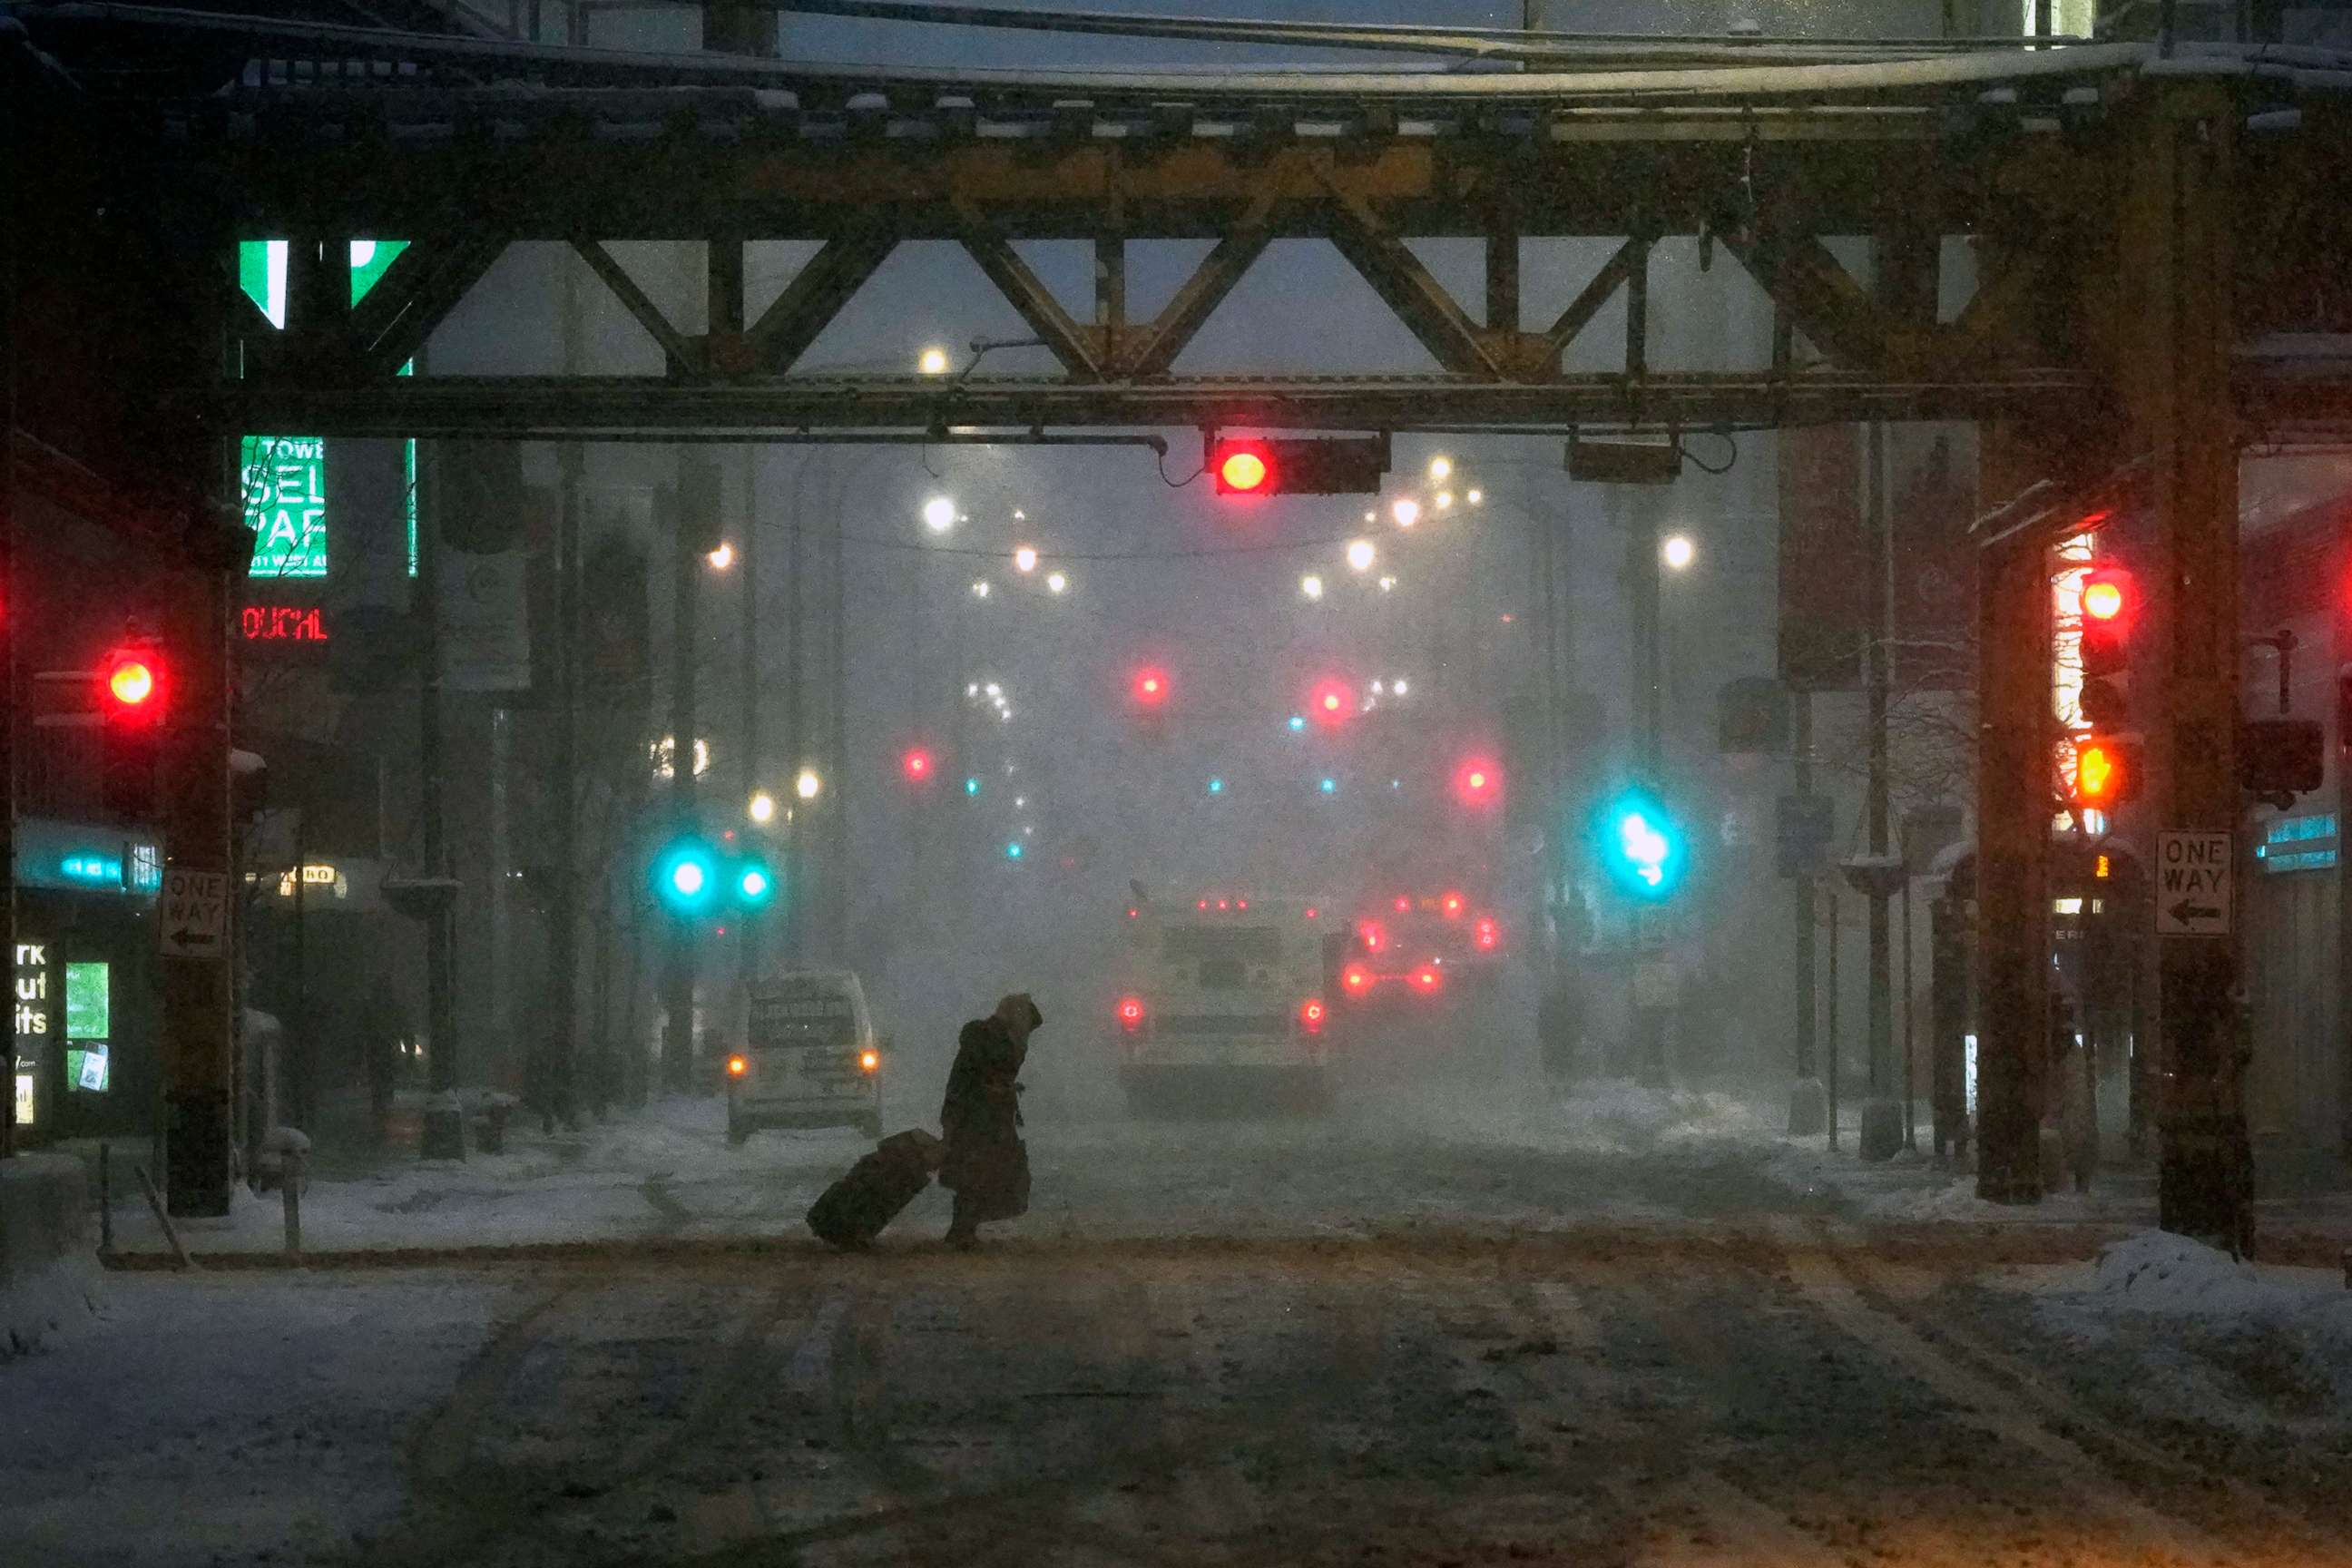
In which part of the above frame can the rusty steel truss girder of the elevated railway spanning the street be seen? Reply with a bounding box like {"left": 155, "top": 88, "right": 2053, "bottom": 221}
{"left": 18, "top": 7, "right": 2352, "bottom": 435}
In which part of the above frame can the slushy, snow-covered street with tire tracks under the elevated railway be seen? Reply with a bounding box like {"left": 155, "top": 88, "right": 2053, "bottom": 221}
{"left": 18, "top": 1086, "right": 2352, "bottom": 1568}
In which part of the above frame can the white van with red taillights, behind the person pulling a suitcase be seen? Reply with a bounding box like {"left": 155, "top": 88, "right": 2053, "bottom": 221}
{"left": 727, "top": 968, "right": 882, "bottom": 1145}
